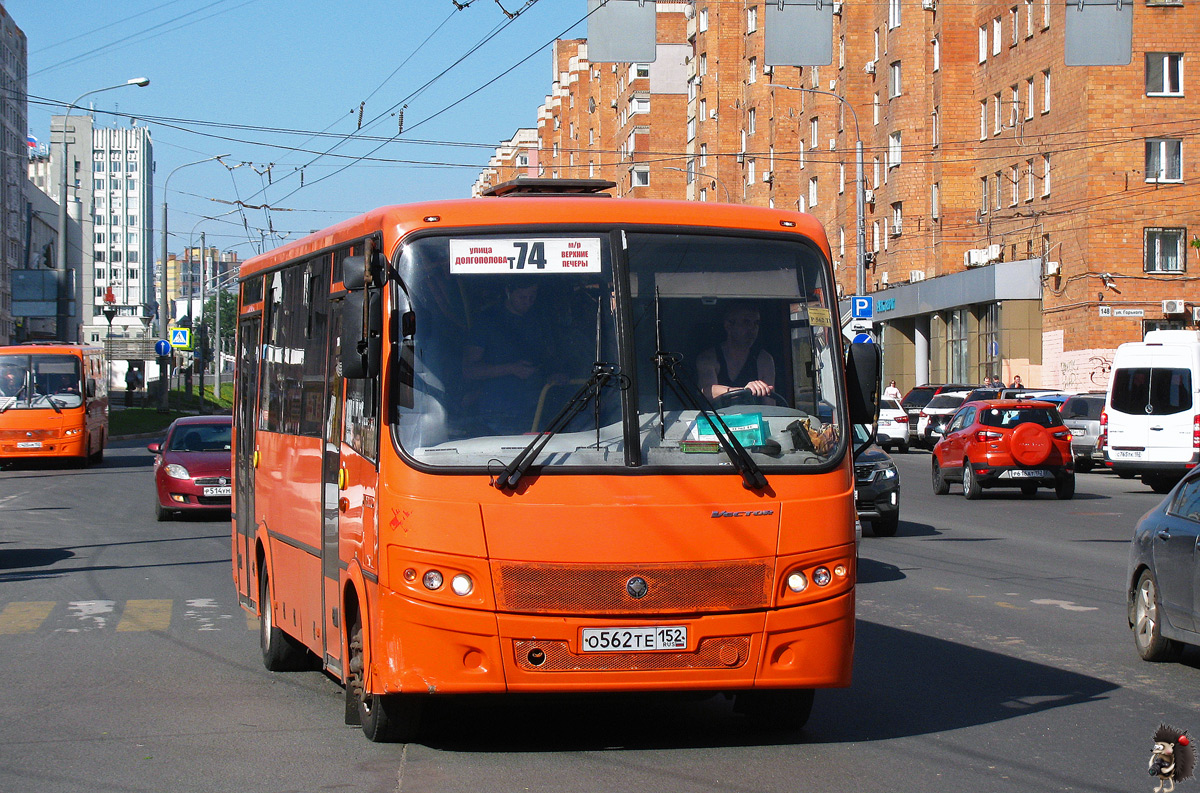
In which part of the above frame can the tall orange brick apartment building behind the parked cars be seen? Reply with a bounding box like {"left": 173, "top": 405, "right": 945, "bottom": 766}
{"left": 480, "top": 0, "right": 1200, "bottom": 390}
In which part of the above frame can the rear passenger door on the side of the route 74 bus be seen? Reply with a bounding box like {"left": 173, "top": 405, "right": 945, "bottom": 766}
{"left": 233, "top": 317, "right": 262, "bottom": 603}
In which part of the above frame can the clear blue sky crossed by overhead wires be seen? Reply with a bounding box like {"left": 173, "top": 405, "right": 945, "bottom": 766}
{"left": 4, "top": 0, "right": 587, "bottom": 258}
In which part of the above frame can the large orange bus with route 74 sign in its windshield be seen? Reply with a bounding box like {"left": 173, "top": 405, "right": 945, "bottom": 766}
{"left": 233, "top": 180, "right": 878, "bottom": 740}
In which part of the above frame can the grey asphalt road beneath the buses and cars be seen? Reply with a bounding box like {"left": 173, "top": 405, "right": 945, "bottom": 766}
{"left": 0, "top": 441, "right": 1200, "bottom": 793}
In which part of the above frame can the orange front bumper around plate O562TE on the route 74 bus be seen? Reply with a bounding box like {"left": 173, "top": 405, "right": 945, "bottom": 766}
{"left": 371, "top": 589, "right": 854, "bottom": 693}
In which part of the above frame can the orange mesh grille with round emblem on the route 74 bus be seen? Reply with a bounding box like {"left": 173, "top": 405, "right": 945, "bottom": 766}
{"left": 492, "top": 560, "right": 772, "bottom": 614}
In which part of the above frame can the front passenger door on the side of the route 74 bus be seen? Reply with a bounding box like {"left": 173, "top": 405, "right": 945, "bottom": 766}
{"left": 320, "top": 299, "right": 343, "bottom": 674}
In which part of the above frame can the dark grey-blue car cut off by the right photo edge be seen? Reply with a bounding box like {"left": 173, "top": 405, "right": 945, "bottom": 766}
{"left": 1126, "top": 469, "right": 1200, "bottom": 661}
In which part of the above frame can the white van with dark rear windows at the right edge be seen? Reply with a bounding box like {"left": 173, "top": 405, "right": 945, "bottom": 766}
{"left": 1104, "top": 330, "right": 1200, "bottom": 493}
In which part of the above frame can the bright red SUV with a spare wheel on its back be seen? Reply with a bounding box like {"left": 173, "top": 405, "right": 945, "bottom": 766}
{"left": 934, "top": 399, "right": 1075, "bottom": 499}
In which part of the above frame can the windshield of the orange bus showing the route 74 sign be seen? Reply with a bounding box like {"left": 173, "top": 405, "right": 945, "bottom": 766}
{"left": 391, "top": 230, "right": 844, "bottom": 469}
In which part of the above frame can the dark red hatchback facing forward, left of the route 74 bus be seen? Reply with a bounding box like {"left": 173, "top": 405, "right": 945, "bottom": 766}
{"left": 146, "top": 416, "right": 233, "bottom": 521}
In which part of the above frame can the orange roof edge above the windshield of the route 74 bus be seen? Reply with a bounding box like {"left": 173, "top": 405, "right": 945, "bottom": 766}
{"left": 239, "top": 196, "right": 830, "bottom": 278}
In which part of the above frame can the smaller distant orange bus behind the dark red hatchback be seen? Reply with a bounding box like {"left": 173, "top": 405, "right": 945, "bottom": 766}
{"left": 0, "top": 342, "right": 108, "bottom": 465}
